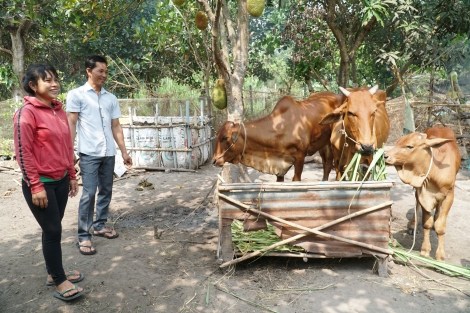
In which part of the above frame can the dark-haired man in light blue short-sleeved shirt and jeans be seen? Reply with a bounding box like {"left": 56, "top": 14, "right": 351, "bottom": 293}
{"left": 66, "top": 55, "right": 132, "bottom": 255}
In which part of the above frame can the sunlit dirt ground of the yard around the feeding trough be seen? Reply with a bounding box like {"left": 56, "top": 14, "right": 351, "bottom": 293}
{"left": 0, "top": 156, "right": 470, "bottom": 313}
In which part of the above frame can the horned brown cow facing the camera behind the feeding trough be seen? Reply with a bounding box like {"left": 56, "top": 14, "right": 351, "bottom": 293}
{"left": 320, "top": 85, "right": 390, "bottom": 180}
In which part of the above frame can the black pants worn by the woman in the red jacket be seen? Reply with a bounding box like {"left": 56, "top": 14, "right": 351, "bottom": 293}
{"left": 23, "top": 176, "right": 69, "bottom": 286}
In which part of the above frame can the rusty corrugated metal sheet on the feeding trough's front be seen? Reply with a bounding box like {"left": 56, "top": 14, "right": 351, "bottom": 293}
{"left": 219, "top": 181, "right": 394, "bottom": 257}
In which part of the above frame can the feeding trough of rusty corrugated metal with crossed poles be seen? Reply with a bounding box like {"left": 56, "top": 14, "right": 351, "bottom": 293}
{"left": 217, "top": 181, "right": 394, "bottom": 276}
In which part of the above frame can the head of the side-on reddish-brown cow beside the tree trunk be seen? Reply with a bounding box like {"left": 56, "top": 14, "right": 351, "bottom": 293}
{"left": 212, "top": 121, "right": 245, "bottom": 166}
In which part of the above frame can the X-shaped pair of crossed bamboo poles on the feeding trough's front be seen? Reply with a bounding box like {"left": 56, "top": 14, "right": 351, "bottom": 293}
{"left": 218, "top": 193, "right": 393, "bottom": 268}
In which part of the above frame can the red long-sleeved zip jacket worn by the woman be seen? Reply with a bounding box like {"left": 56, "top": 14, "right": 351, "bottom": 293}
{"left": 13, "top": 97, "right": 76, "bottom": 193}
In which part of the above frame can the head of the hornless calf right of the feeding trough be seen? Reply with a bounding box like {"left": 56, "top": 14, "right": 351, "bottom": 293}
{"left": 384, "top": 133, "right": 454, "bottom": 188}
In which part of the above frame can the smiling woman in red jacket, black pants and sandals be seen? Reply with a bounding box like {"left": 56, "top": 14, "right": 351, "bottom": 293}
{"left": 13, "top": 64, "right": 85, "bottom": 301}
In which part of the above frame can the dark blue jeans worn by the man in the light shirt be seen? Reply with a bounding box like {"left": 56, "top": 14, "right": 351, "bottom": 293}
{"left": 78, "top": 153, "right": 115, "bottom": 242}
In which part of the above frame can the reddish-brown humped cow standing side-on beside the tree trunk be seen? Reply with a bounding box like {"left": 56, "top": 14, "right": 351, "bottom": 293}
{"left": 212, "top": 91, "right": 341, "bottom": 182}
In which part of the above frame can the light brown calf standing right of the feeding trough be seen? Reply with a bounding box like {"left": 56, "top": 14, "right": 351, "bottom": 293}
{"left": 385, "top": 127, "right": 460, "bottom": 261}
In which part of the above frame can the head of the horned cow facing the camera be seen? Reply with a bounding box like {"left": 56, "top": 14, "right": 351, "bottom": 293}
{"left": 320, "top": 85, "right": 385, "bottom": 155}
